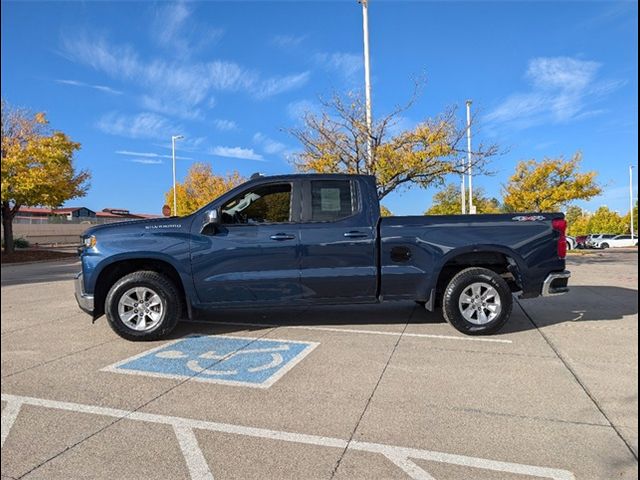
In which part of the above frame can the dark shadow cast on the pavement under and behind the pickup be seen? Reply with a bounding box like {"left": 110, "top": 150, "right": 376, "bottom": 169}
{"left": 171, "top": 285, "right": 638, "bottom": 338}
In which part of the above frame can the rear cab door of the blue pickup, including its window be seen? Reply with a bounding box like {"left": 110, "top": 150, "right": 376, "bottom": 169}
{"left": 300, "top": 179, "right": 377, "bottom": 303}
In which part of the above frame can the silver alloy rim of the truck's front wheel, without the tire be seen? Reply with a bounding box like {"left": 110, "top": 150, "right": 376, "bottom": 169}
{"left": 118, "top": 287, "right": 164, "bottom": 332}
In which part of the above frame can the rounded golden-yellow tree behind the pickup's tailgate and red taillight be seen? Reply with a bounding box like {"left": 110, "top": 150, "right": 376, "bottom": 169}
{"left": 503, "top": 152, "right": 602, "bottom": 212}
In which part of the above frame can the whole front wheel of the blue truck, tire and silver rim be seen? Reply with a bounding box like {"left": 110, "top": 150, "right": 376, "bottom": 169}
{"left": 104, "top": 271, "right": 182, "bottom": 340}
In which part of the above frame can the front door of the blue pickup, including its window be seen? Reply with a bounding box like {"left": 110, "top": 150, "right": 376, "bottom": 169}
{"left": 191, "top": 182, "right": 302, "bottom": 305}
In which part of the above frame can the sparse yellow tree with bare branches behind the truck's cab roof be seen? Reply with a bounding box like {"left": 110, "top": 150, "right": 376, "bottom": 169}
{"left": 289, "top": 85, "right": 498, "bottom": 199}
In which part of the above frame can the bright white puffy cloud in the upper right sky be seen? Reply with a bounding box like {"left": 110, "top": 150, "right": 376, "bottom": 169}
{"left": 485, "top": 57, "right": 624, "bottom": 128}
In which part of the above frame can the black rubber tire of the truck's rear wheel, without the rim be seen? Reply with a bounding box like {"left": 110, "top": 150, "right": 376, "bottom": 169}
{"left": 442, "top": 267, "right": 513, "bottom": 335}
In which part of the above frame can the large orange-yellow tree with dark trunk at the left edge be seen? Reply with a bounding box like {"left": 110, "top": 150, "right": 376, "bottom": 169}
{"left": 2, "top": 100, "right": 91, "bottom": 253}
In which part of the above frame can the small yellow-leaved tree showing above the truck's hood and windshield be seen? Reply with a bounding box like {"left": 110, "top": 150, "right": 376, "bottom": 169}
{"left": 165, "top": 163, "right": 246, "bottom": 215}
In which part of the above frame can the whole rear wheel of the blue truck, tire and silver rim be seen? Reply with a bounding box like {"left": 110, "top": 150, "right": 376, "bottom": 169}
{"left": 442, "top": 267, "right": 513, "bottom": 335}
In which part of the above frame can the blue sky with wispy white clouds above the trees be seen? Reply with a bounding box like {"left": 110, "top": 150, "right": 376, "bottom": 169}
{"left": 2, "top": 0, "right": 638, "bottom": 215}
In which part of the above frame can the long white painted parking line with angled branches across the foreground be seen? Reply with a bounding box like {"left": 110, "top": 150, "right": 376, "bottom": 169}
{"left": 2, "top": 393, "right": 574, "bottom": 480}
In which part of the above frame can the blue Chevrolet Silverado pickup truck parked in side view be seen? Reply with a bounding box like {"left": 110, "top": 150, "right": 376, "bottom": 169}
{"left": 75, "top": 174, "right": 570, "bottom": 340}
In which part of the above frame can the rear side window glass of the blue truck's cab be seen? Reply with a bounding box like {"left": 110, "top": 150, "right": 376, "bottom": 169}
{"left": 311, "top": 180, "right": 355, "bottom": 222}
